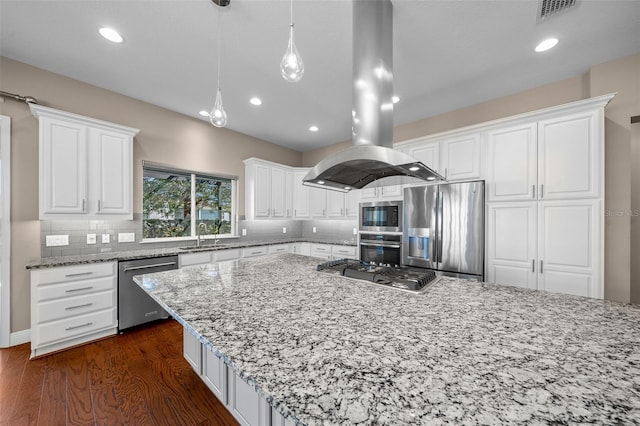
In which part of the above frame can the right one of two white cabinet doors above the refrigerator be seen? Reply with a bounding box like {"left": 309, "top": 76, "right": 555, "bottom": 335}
{"left": 440, "top": 134, "right": 481, "bottom": 180}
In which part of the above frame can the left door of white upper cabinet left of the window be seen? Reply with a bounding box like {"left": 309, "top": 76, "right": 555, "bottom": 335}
{"left": 40, "top": 117, "right": 88, "bottom": 216}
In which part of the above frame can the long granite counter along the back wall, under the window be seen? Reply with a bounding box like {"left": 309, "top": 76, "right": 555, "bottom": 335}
{"left": 26, "top": 238, "right": 356, "bottom": 269}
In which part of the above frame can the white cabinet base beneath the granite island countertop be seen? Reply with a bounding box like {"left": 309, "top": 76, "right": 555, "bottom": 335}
{"left": 183, "top": 328, "right": 286, "bottom": 426}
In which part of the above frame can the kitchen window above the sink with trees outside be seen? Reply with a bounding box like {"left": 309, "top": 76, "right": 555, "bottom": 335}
{"left": 142, "top": 164, "right": 238, "bottom": 241}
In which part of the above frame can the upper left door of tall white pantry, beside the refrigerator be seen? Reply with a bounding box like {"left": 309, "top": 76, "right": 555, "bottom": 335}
{"left": 487, "top": 123, "right": 537, "bottom": 201}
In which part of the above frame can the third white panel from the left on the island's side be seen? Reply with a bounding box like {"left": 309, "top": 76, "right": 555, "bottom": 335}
{"left": 228, "top": 367, "right": 271, "bottom": 426}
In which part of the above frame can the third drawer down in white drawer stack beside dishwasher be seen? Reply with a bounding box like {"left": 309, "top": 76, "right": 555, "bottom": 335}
{"left": 36, "top": 290, "right": 116, "bottom": 323}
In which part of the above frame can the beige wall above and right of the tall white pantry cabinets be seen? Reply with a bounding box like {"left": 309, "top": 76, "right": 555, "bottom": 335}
{"left": 302, "top": 55, "right": 640, "bottom": 302}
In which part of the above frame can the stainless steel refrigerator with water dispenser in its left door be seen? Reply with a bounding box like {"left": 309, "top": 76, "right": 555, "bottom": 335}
{"left": 402, "top": 181, "right": 484, "bottom": 281}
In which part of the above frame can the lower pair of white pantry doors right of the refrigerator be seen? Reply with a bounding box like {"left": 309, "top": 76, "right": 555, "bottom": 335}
{"left": 487, "top": 200, "right": 604, "bottom": 298}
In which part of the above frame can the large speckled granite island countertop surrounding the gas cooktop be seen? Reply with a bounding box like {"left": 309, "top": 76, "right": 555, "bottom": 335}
{"left": 139, "top": 254, "right": 640, "bottom": 425}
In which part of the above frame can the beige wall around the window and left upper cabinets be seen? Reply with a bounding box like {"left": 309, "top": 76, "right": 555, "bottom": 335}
{"left": 0, "top": 58, "right": 302, "bottom": 332}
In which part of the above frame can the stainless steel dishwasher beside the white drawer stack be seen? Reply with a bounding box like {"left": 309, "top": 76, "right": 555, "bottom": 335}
{"left": 118, "top": 256, "right": 178, "bottom": 331}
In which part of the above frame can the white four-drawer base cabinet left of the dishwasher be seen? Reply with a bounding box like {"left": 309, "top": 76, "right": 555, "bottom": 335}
{"left": 31, "top": 262, "right": 118, "bottom": 358}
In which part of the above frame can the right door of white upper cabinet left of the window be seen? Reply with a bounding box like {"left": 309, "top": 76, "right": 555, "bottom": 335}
{"left": 90, "top": 129, "right": 133, "bottom": 215}
